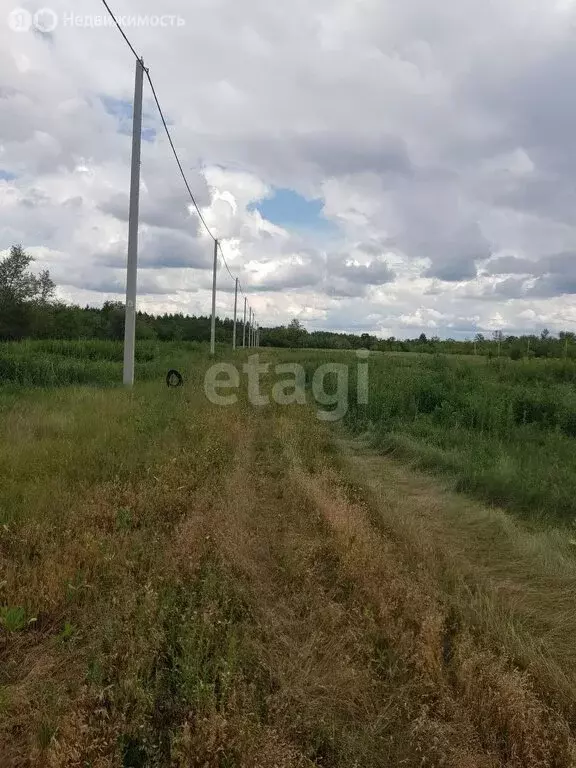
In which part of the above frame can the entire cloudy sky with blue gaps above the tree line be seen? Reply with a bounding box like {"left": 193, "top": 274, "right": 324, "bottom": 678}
{"left": 0, "top": 0, "right": 576, "bottom": 338}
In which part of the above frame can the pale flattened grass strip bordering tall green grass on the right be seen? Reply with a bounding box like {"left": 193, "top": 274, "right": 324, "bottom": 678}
{"left": 340, "top": 440, "right": 576, "bottom": 720}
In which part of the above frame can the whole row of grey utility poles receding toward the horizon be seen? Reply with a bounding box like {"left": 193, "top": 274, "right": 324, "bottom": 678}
{"left": 123, "top": 59, "right": 260, "bottom": 387}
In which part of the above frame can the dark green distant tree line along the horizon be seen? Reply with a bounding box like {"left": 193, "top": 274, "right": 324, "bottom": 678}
{"left": 0, "top": 245, "right": 576, "bottom": 360}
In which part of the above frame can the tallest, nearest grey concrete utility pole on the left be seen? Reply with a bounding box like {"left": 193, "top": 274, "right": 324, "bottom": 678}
{"left": 123, "top": 59, "right": 144, "bottom": 387}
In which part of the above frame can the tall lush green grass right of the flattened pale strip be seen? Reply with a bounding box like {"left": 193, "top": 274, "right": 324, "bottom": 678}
{"left": 272, "top": 351, "right": 576, "bottom": 526}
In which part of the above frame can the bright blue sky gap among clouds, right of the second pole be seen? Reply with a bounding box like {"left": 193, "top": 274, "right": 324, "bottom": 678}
{"left": 249, "top": 188, "right": 336, "bottom": 233}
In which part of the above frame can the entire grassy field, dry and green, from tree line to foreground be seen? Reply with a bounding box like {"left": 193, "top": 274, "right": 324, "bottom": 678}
{"left": 0, "top": 343, "right": 576, "bottom": 768}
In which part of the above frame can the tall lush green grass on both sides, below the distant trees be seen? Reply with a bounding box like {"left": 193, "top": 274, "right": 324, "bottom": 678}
{"left": 0, "top": 341, "right": 576, "bottom": 525}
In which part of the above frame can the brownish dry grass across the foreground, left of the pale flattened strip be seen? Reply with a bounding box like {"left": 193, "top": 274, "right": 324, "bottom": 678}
{"left": 0, "top": 356, "right": 574, "bottom": 768}
